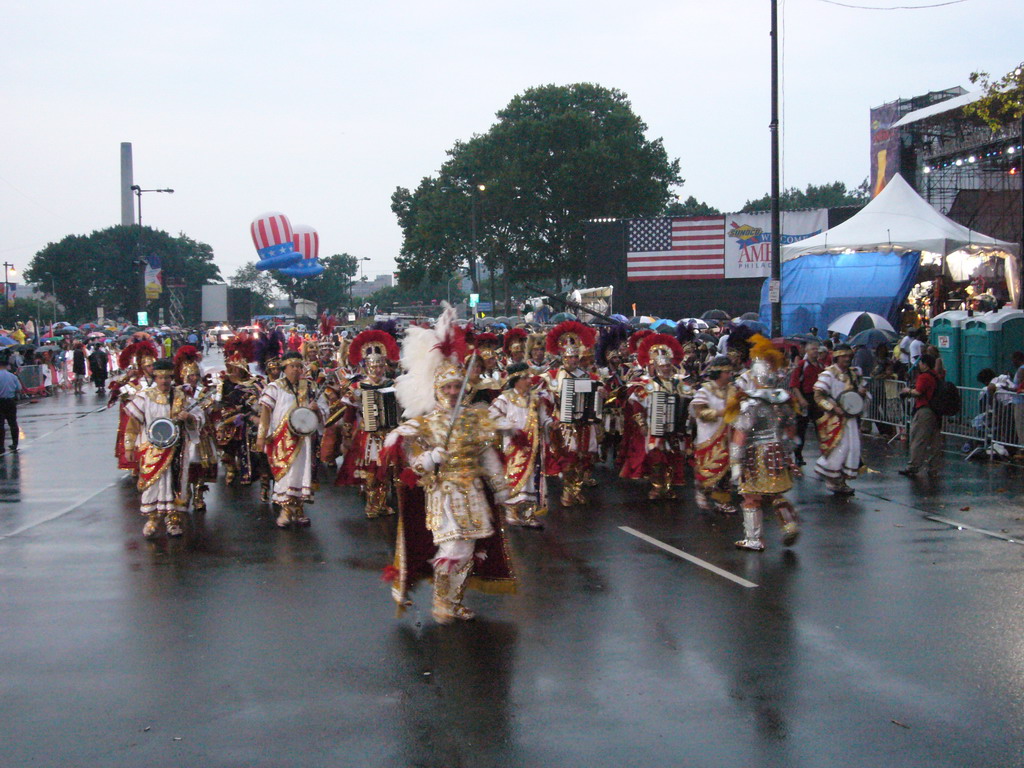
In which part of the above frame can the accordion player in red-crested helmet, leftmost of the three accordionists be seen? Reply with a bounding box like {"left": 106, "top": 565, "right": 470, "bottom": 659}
{"left": 335, "top": 330, "right": 399, "bottom": 517}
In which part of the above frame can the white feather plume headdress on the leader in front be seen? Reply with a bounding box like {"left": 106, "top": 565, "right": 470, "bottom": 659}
{"left": 394, "top": 302, "right": 466, "bottom": 419}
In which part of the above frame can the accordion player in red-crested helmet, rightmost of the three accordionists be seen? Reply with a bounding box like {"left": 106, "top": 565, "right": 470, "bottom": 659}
{"left": 620, "top": 334, "right": 694, "bottom": 499}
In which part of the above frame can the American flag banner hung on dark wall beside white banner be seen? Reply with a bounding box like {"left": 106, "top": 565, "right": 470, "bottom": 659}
{"left": 626, "top": 216, "right": 725, "bottom": 283}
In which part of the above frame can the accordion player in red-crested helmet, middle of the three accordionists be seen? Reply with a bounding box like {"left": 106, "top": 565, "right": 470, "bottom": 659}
{"left": 544, "top": 321, "right": 605, "bottom": 507}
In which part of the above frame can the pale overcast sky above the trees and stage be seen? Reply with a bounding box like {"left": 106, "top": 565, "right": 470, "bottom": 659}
{"left": 0, "top": 0, "right": 1024, "bottom": 278}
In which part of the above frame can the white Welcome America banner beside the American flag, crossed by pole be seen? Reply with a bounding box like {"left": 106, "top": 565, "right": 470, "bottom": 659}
{"left": 725, "top": 208, "right": 828, "bottom": 280}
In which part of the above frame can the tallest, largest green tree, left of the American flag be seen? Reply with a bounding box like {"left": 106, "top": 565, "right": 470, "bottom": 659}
{"left": 391, "top": 83, "right": 682, "bottom": 294}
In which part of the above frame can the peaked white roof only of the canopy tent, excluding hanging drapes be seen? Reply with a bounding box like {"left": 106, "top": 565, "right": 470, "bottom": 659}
{"left": 782, "top": 173, "right": 1018, "bottom": 261}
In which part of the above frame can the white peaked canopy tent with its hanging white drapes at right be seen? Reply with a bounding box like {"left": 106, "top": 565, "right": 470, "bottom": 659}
{"left": 782, "top": 173, "right": 1021, "bottom": 304}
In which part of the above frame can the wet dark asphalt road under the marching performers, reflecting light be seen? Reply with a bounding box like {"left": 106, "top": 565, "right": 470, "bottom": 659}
{"left": 0, "top": 374, "right": 1024, "bottom": 768}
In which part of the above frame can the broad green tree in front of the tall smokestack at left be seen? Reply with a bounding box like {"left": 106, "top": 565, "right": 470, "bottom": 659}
{"left": 25, "top": 225, "right": 220, "bottom": 321}
